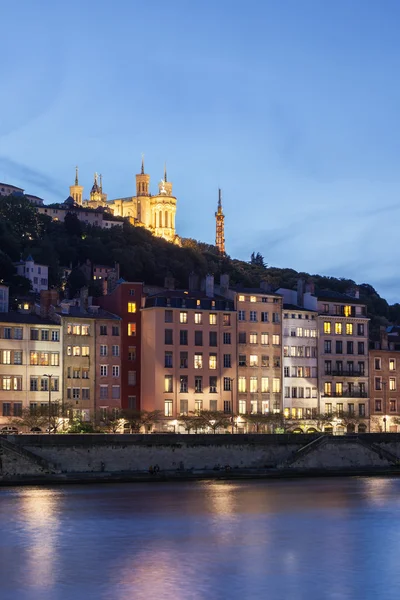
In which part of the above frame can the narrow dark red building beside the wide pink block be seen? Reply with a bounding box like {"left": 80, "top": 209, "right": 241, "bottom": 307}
{"left": 96, "top": 279, "right": 143, "bottom": 410}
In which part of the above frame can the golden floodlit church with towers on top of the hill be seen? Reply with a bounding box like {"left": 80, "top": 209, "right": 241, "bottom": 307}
{"left": 69, "top": 159, "right": 179, "bottom": 243}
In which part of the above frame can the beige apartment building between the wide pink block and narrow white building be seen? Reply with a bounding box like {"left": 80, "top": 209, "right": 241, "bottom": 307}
{"left": 230, "top": 288, "right": 283, "bottom": 414}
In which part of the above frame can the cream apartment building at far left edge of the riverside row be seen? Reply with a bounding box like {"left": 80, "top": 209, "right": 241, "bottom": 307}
{"left": 0, "top": 313, "right": 63, "bottom": 426}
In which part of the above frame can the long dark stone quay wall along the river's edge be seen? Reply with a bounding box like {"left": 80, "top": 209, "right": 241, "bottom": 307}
{"left": 0, "top": 434, "right": 400, "bottom": 482}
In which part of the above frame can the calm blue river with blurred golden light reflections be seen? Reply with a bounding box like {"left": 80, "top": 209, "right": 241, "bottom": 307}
{"left": 0, "top": 477, "right": 400, "bottom": 600}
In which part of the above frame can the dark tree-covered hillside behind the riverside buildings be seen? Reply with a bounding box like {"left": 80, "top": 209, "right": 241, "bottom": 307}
{"left": 0, "top": 195, "right": 400, "bottom": 332}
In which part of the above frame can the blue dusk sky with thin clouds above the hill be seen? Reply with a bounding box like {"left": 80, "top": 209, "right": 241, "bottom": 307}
{"left": 0, "top": 0, "right": 400, "bottom": 302}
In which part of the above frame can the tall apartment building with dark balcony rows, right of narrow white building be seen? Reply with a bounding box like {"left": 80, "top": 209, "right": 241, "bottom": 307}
{"left": 316, "top": 291, "right": 369, "bottom": 431}
